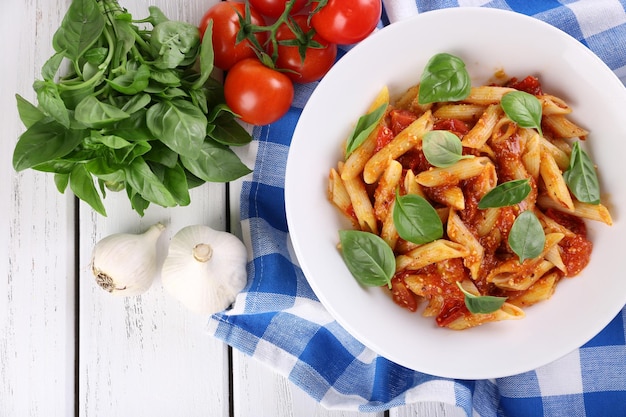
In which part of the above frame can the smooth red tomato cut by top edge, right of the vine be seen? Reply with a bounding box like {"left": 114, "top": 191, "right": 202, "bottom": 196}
{"left": 311, "top": 0, "right": 382, "bottom": 45}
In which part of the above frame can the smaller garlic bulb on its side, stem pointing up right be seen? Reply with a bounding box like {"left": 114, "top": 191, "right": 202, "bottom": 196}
{"left": 91, "top": 223, "right": 165, "bottom": 296}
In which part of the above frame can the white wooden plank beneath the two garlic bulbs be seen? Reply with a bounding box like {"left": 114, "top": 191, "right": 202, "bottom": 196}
{"left": 78, "top": 0, "right": 229, "bottom": 417}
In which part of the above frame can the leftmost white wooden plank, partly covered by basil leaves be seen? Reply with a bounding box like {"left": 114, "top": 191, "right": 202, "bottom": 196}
{"left": 0, "top": 0, "right": 74, "bottom": 416}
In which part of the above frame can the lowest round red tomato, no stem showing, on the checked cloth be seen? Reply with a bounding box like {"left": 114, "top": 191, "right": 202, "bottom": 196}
{"left": 224, "top": 58, "right": 294, "bottom": 126}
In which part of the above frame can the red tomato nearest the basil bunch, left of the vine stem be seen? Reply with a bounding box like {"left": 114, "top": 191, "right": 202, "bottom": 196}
{"left": 199, "top": 1, "right": 267, "bottom": 70}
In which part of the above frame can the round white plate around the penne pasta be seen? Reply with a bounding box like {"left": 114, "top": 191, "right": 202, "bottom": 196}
{"left": 285, "top": 8, "right": 626, "bottom": 379}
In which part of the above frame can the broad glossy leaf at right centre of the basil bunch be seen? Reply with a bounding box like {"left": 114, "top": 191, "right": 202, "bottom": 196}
{"left": 146, "top": 100, "right": 207, "bottom": 158}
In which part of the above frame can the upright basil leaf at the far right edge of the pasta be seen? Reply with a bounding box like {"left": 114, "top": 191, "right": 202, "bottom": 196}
{"left": 563, "top": 141, "right": 600, "bottom": 204}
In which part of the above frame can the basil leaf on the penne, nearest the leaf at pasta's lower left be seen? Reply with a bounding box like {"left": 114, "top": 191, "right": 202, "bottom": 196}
{"left": 392, "top": 191, "right": 443, "bottom": 244}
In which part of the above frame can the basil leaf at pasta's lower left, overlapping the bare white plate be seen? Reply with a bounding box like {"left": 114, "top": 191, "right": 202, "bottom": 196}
{"left": 339, "top": 230, "right": 396, "bottom": 287}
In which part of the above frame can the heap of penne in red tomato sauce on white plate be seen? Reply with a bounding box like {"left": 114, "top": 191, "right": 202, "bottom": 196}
{"left": 328, "top": 65, "right": 612, "bottom": 330}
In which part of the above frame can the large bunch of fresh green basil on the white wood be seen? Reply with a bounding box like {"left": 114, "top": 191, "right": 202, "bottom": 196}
{"left": 13, "top": 0, "right": 251, "bottom": 215}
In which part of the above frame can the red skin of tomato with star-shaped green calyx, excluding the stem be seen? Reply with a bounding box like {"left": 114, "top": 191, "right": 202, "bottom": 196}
{"left": 268, "top": 15, "right": 337, "bottom": 83}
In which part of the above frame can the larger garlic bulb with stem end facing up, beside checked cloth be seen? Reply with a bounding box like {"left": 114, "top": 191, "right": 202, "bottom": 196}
{"left": 161, "top": 225, "right": 247, "bottom": 314}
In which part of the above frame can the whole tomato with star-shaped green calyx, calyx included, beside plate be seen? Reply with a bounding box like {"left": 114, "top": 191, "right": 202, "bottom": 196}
{"left": 268, "top": 15, "right": 337, "bottom": 83}
